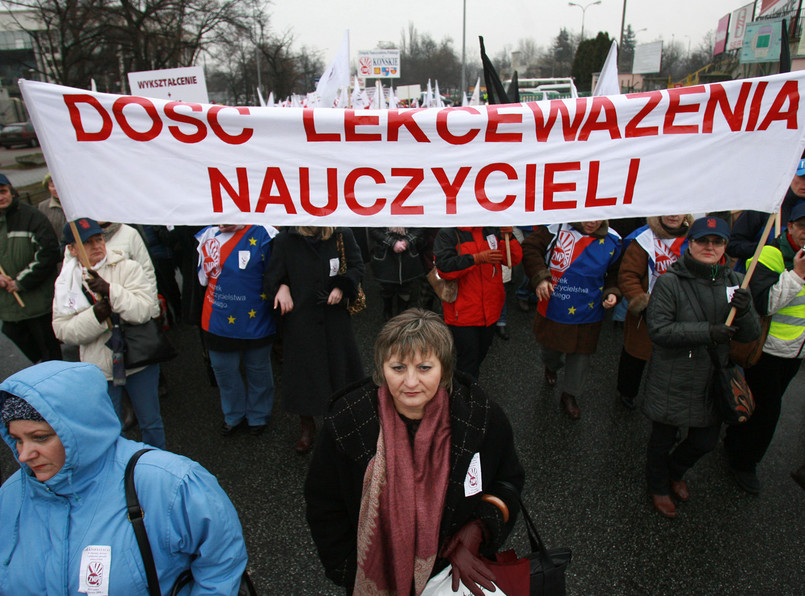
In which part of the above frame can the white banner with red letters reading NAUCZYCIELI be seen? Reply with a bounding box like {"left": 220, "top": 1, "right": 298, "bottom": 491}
{"left": 20, "top": 71, "right": 805, "bottom": 227}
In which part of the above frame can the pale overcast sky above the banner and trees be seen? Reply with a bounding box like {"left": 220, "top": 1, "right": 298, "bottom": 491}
{"left": 268, "top": 0, "right": 749, "bottom": 65}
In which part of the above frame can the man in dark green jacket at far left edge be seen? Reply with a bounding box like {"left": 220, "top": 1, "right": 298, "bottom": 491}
{"left": 0, "top": 174, "right": 61, "bottom": 362}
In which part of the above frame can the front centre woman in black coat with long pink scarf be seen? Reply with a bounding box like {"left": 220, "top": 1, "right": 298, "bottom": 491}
{"left": 305, "top": 309, "right": 523, "bottom": 595}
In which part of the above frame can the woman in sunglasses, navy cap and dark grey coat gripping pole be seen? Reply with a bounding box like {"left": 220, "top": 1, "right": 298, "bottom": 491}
{"left": 643, "top": 216, "right": 760, "bottom": 517}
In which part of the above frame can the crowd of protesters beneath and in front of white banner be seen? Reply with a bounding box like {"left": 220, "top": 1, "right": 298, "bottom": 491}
{"left": 0, "top": 154, "right": 805, "bottom": 594}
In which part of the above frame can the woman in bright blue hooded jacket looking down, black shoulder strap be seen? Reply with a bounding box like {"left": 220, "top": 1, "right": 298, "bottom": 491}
{"left": 0, "top": 361, "right": 246, "bottom": 596}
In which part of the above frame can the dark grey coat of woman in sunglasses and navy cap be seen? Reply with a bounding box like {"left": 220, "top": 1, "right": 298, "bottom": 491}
{"left": 643, "top": 252, "right": 760, "bottom": 428}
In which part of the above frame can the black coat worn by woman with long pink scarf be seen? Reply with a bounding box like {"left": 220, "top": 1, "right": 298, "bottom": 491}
{"left": 305, "top": 372, "right": 524, "bottom": 587}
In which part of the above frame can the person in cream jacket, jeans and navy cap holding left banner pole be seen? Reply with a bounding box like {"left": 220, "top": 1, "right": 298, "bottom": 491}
{"left": 53, "top": 217, "right": 165, "bottom": 449}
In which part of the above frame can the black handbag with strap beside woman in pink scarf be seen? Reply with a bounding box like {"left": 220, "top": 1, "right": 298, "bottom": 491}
{"left": 489, "top": 481, "right": 573, "bottom": 596}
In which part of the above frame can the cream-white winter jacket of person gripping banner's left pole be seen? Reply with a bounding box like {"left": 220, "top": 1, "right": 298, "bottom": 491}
{"left": 53, "top": 249, "right": 159, "bottom": 381}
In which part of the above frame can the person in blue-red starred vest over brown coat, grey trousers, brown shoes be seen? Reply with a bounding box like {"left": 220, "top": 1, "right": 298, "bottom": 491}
{"left": 523, "top": 220, "right": 621, "bottom": 420}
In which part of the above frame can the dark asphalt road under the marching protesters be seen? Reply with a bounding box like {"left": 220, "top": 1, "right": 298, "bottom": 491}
{"left": 0, "top": 272, "right": 805, "bottom": 595}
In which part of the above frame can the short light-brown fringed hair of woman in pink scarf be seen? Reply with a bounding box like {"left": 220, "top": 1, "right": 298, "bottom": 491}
{"left": 372, "top": 308, "right": 456, "bottom": 391}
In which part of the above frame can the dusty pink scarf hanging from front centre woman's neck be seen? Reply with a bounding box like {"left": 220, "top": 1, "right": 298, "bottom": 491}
{"left": 355, "top": 384, "right": 450, "bottom": 596}
